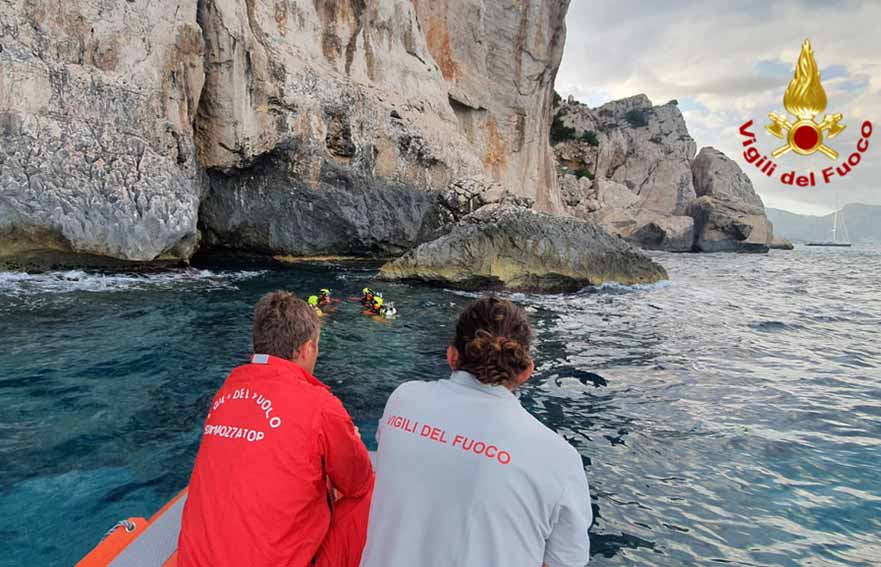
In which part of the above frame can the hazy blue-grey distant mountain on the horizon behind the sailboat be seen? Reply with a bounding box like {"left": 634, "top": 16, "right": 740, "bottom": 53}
{"left": 766, "top": 203, "right": 881, "bottom": 242}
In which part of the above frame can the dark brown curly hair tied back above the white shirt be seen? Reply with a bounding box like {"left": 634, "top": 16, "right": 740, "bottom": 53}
{"left": 453, "top": 297, "right": 533, "bottom": 387}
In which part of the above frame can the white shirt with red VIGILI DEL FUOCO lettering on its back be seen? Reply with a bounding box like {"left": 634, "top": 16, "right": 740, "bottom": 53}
{"left": 362, "top": 372, "right": 592, "bottom": 567}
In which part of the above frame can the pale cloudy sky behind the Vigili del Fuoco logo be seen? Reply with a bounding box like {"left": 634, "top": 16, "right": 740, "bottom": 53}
{"left": 556, "top": 0, "right": 881, "bottom": 214}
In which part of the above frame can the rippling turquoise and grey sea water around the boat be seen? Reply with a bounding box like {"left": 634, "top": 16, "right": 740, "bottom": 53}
{"left": 0, "top": 247, "right": 881, "bottom": 566}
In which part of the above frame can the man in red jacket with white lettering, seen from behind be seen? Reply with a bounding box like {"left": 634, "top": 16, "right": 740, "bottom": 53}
{"left": 178, "top": 291, "right": 373, "bottom": 567}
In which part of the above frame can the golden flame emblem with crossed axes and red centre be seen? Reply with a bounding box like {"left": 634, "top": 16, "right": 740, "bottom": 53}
{"left": 765, "top": 40, "right": 847, "bottom": 159}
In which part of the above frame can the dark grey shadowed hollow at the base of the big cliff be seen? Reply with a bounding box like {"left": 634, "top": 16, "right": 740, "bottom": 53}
{"left": 199, "top": 143, "right": 443, "bottom": 257}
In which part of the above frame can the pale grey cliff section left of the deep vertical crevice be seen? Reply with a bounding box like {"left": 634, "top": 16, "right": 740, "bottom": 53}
{"left": 0, "top": 0, "right": 204, "bottom": 261}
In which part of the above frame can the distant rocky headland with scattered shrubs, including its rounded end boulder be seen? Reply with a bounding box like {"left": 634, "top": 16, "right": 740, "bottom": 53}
{"left": 551, "top": 95, "right": 773, "bottom": 252}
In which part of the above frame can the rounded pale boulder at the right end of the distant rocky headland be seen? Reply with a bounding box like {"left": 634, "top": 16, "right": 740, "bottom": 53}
{"left": 688, "top": 148, "right": 772, "bottom": 252}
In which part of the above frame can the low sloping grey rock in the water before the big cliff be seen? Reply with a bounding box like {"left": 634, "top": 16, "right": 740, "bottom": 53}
{"left": 380, "top": 206, "right": 667, "bottom": 291}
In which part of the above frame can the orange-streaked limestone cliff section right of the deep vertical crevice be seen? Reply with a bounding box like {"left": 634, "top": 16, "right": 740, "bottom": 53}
{"left": 197, "top": 0, "right": 566, "bottom": 254}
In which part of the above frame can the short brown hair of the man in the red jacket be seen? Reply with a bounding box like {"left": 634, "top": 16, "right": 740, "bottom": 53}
{"left": 254, "top": 291, "right": 321, "bottom": 360}
